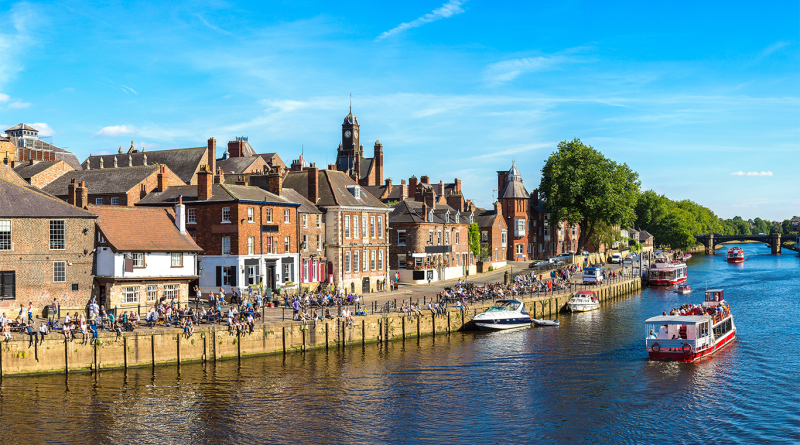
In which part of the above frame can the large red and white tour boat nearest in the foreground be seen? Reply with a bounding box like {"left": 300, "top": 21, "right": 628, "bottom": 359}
{"left": 644, "top": 289, "right": 736, "bottom": 362}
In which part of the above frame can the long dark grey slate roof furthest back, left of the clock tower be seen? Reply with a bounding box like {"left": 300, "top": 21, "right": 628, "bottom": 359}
{"left": 83, "top": 147, "right": 208, "bottom": 184}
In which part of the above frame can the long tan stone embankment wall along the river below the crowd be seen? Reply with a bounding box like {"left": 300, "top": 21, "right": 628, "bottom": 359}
{"left": 0, "top": 279, "right": 641, "bottom": 376}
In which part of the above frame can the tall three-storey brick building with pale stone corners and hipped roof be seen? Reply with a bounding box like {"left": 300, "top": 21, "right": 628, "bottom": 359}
{"left": 283, "top": 164, "right": 391, "bottom": 293}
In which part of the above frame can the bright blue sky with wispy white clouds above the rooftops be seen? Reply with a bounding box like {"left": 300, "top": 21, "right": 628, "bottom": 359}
{"left": 0, "top": 0, "right": 800, "bottom": 219}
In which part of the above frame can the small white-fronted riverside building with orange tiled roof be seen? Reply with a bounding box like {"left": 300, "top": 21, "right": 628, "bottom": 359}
{"left": 88, "top": 200, "right": 202, "bottom": 310}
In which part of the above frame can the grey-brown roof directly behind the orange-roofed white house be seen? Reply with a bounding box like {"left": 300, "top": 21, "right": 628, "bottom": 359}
{"left": 42, "top": 165, "right": 158, "bottom": 196}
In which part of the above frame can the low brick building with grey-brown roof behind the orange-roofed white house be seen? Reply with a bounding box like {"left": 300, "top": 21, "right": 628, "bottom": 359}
{"left": 42, "top": 165, "right": 184, "bottom": 206}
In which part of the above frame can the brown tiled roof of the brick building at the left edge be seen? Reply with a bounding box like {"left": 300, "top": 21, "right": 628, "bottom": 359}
{"left": 0, "top": 179, "right": 95, "bottom": 218}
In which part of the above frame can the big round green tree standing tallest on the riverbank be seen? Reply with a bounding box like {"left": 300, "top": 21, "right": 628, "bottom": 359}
{"left": 539, "top": 139, "right": 641, "bottom": 251}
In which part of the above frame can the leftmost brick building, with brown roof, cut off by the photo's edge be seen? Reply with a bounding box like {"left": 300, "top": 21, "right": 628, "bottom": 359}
{"left": 0, "top": 176, "right": 97, "bottom": 317}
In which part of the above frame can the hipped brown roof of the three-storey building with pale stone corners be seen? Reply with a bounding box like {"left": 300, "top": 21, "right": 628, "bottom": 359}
{"left": 283, "top": 170, "right": 386, "bottom": 209}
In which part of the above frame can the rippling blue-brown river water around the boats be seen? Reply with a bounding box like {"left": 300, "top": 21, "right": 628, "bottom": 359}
{"left": 0, "top": 244, "right": 800, "bottom": 443}
